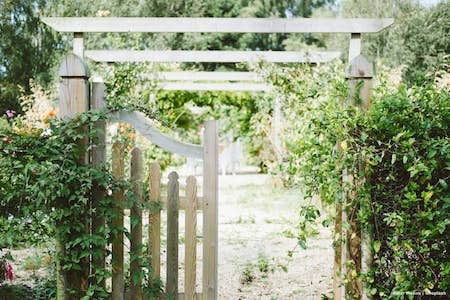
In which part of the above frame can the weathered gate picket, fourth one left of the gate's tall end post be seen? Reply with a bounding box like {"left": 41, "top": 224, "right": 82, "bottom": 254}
{"left": 130, "top": 147, "right": 143, "bottom": 300}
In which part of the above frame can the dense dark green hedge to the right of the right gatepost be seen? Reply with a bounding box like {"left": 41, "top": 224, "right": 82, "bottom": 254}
{"left": 351, "top": 85, "right": 450, "bottom": 297}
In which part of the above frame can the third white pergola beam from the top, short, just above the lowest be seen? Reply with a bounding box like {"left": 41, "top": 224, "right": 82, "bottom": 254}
{"left": 156, "top": 71, "right": 262, "bottom": 81}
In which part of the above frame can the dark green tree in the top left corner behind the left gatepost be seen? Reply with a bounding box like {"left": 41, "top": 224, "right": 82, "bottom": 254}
{"left": 0, "top": 0, "right": 62, "bottom": 114}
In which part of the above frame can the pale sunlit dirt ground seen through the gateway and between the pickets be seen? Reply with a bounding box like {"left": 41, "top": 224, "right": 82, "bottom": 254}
{"left": 6, "top": 174, "right": 333, "bottom": 300}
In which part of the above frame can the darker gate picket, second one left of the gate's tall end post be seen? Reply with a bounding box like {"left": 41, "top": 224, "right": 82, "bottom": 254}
{"left": 166, "top": 172, "right": 180, "bottom": 299}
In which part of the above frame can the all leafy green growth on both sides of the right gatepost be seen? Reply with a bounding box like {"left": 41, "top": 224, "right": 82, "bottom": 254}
{"left": 271, "top": 60, "right": 450, "bottom": 299}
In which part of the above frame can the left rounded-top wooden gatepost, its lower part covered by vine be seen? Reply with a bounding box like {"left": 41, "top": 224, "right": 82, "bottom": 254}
{"left": 57, "top": 54, "right": 90, "bottom": 299}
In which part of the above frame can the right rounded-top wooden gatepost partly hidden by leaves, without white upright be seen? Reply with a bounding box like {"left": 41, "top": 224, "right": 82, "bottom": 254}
{"left": 344, "top": 55, "right": 373, "bottom": 299}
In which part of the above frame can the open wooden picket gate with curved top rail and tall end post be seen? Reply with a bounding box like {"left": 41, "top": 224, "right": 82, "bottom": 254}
{"left": 106, "top": 111, "right": 218, "bottom": 299}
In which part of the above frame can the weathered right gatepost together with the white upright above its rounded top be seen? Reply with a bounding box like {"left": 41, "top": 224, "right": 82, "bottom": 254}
{"left": 333, "top": 54, "right": 373, "bottom": 300}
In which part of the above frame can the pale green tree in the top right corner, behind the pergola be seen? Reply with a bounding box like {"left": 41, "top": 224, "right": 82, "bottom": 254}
{"left": 340, "top": 0, "right": 450, "bottom": 85}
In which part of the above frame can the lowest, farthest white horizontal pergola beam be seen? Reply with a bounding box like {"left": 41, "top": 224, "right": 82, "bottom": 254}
{"left": 159, "top": 82, "right": 272, "bottom": 92}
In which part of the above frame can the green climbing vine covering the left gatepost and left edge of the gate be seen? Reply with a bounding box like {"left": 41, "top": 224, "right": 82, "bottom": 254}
{"left": 0, "top": 111, "right": 160, "bottom": 299}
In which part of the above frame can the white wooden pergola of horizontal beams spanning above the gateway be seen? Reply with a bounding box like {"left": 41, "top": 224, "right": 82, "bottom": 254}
{"left": 42, "top": 18, "right": 393, "bottom": 91}
